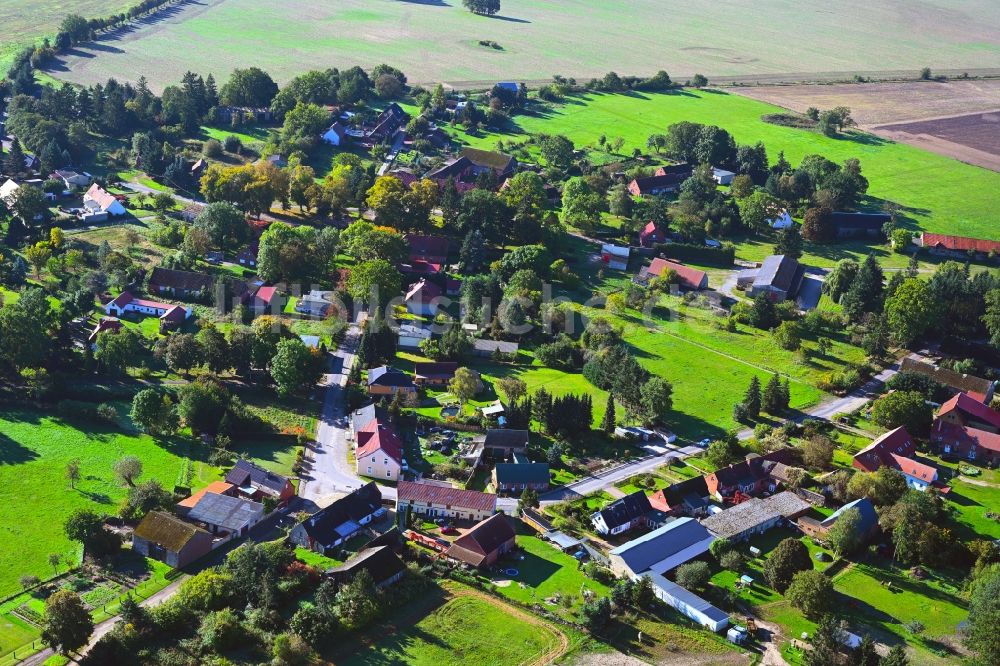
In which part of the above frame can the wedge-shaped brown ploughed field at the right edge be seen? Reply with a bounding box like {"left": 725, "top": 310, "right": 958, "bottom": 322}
{"left": 871, "top": 110, "right": 1000, "bottom": 171}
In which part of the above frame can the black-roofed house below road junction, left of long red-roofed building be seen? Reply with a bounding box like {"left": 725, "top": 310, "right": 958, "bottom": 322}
{"left": 288, "top": 481, "right": 386, "bottom": 555}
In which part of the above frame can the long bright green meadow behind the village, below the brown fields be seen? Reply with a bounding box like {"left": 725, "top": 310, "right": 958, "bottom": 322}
{"left": 452, "top": 89, "right": 1000, "bottom": 237}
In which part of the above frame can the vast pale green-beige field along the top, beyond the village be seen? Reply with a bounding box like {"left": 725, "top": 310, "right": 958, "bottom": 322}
{"left": 47, "top": 0, "right": 1000, "bottom": 87}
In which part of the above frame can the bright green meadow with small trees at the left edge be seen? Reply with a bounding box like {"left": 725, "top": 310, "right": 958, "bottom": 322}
{"left": 0, "top": 410, "right": 219, "bottom": 596}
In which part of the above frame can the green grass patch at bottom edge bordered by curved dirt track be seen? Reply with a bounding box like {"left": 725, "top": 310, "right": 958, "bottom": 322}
{"left": 338, "top": 596, "right": 558, "bottom": 666}
